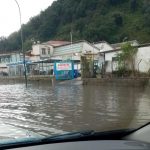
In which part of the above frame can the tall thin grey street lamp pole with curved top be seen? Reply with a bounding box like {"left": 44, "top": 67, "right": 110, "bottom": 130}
{"left": 14, "top": 0, "right": 27, "bottom": 87}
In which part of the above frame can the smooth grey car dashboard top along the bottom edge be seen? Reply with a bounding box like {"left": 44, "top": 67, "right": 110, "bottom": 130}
{"left": 9, "top": 140, "right": 150, "bottom": 150}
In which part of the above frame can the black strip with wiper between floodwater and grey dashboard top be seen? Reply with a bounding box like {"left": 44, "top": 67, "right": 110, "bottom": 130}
{"left": 0, "top": 123, "right": 150, "bottom": 149}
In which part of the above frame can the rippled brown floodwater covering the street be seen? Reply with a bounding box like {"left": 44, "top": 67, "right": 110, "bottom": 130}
{"left": 0, "top": 82, "right": 150, "bottom": 136}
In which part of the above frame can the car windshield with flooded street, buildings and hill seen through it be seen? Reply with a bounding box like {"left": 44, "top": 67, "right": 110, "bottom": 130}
{"left": 0, "top": 0, "right": 150, "bottom": 142}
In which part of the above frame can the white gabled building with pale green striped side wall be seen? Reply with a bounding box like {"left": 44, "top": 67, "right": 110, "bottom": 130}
{"left": 52, "top": 41, "right": 103, "bottom": 69}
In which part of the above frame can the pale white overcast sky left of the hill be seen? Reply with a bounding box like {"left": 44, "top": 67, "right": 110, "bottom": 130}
{"left": 0, "top": 0, "right": 54, "bottom": 36}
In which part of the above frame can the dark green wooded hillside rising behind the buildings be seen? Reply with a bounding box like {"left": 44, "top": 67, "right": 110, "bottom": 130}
{"left": 0, "top": 0, "right": 150, "bottom": 51}
